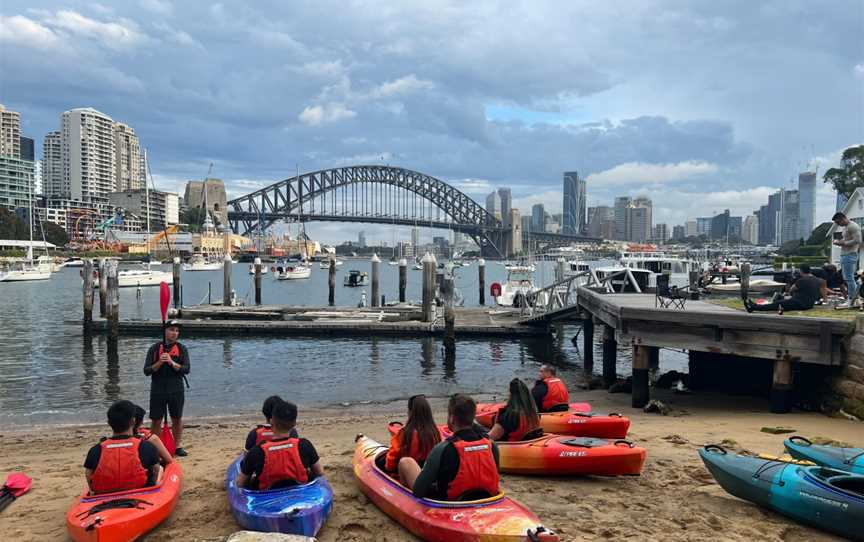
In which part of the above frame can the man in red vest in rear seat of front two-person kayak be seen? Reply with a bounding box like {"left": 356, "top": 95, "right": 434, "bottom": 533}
{"left": 399, "top": 393, "right": 500, "bottom": 501}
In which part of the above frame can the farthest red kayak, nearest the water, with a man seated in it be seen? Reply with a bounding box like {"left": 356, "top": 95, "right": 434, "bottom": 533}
{"left": 475, "top": 403, "right": 630, "bottom": 439}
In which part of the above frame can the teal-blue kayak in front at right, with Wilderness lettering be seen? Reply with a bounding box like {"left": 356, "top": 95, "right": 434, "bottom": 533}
{"left": 699, "top": 445, "right": 864, "bottom": 540}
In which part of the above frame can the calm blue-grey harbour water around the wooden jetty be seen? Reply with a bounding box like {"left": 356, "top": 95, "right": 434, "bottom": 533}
{"left": 0, "top": 260, "right": 681, "bottom": 425}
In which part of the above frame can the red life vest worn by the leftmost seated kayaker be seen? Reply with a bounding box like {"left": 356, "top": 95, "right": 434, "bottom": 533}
{"left": 90, "top": 437, "right": 148, "bottom": 493}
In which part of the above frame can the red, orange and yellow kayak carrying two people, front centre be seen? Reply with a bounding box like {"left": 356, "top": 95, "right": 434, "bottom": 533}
{"left": 354, "top": 435, "right": 559, "bottom": 542}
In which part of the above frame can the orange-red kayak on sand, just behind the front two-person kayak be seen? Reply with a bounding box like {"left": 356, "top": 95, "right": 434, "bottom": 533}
{"left": 387, "top": 422, "right": 646, "bottom": 476}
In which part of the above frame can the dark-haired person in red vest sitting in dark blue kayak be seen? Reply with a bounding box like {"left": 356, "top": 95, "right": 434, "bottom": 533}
{"left": 237, "top": 401, "right": 324, "bottom": 491}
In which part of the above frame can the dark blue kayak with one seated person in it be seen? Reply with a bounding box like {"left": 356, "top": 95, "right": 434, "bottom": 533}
{"left": 225, "top": 456, "right": 333, "bottom": 536}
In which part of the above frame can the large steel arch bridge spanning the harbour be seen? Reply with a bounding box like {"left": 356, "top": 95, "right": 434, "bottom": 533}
{"left": 227, "top": 165, "right": 595, "bottom": 258}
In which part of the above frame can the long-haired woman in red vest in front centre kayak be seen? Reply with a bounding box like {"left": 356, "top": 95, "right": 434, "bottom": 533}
{"left": 384, "top": 395, "right": 441, "bottom": 484}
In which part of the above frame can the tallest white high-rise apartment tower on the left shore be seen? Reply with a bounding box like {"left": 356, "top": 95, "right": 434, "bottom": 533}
{"left": 60, "top": 107, "right": 117, "bottom": 202}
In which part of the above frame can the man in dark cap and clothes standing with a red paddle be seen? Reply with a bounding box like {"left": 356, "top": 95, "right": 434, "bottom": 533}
{"left": 144, "top": 320, "right": 191, "bottom": 457}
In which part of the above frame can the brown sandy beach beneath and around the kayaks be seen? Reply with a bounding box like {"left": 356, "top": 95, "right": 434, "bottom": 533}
{"left": 0, "top": 391, "right": 864, "bottom": 542}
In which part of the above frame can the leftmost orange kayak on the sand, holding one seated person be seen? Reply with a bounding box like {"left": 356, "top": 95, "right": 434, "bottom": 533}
{"left": 66, "top": 461, "right": 183, "bottom": 542}
